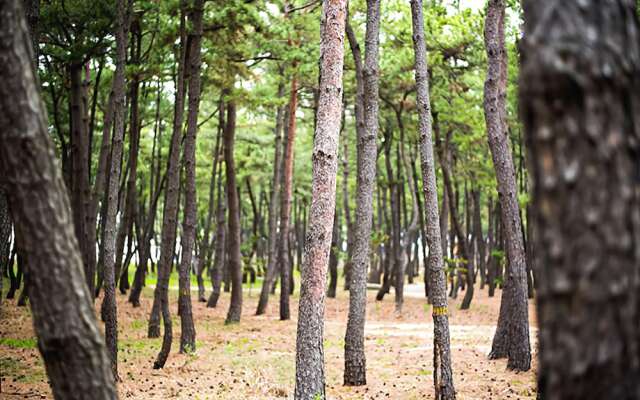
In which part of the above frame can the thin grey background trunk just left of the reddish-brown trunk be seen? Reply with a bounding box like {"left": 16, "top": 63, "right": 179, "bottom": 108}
{"left": 256, "top": 83, "right": 285, "bottom": 315}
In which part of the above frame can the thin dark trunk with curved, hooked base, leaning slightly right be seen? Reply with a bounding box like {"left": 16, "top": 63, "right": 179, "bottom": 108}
{"left": 149, "top": 0, "right": 188, "bottom": 369}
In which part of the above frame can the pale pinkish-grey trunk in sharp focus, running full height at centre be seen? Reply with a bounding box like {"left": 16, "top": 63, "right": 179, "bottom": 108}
{"left": 294, "top": 0, "right": 347, "bottom": 400}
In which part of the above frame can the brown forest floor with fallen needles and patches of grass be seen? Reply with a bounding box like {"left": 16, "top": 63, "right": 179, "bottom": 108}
{"left": 0, "top": 278, "right": 537, "bottom": 400}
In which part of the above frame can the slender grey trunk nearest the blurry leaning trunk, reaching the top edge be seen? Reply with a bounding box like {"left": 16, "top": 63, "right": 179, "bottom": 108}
{"left": 102, "top": 0, "right": 130, "bottom": 381}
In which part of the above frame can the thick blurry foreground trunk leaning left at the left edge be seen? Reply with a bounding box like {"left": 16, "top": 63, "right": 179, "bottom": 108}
{"left": 0, "top": 0, "right": 117, "bottom": 399}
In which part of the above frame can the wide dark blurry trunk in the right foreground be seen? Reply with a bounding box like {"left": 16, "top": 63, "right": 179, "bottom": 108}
{"left": 520, "top": 0, "right": 640, "bottom": 400}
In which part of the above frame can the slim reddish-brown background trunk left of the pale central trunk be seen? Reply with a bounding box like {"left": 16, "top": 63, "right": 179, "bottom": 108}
{"left": 278, "top": 75, "right": 298, "bottom": 321}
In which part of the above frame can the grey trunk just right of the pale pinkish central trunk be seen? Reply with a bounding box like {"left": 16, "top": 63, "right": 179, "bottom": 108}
{"left": 344, "top": 0, "right": 380, "bottom": 386}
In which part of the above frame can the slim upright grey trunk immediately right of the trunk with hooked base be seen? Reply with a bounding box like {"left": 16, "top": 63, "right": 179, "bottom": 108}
{"left": 178, "top": 0, "right": 204, "bottom": 353}
